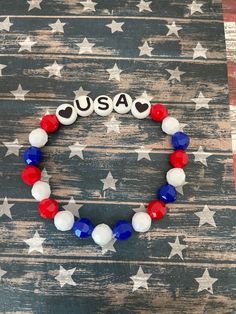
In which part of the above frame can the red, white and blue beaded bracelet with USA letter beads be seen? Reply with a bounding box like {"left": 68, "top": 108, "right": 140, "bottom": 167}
{"left": 21, "top": 93, "right": 190, "bottom": 246}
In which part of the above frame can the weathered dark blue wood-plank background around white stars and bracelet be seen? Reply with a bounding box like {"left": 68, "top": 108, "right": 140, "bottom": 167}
{"left": 0, "top": 0, "right": 236, "bottom": 314}
